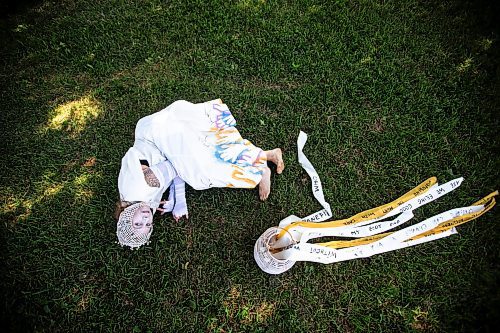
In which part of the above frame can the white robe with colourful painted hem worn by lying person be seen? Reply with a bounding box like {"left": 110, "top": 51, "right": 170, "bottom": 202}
{"left": 118, "top": 99, "right": 266, "bottom": 212}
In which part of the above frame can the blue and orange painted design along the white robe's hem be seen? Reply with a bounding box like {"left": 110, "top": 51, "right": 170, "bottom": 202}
{"left": 207, "top": 100, "right": 267, "bottom": 188}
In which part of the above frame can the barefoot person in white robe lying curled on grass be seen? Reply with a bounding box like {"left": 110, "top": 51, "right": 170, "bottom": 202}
{"left": 115, "top": 99, "right": 285, "bottom": 248}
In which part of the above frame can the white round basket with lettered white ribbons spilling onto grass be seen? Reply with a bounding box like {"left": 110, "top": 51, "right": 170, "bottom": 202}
{"left": 254, "top": 131, "right": 498, "bottom": 274}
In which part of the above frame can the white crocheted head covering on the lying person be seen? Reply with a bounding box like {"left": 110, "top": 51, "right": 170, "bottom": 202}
{"left": 116, "top": 202, "right": 153, "bottom": 249}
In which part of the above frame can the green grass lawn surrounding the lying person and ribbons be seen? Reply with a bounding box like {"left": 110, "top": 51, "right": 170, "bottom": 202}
{"left": 0, "top": 0, "right": 500, "bottom": 332}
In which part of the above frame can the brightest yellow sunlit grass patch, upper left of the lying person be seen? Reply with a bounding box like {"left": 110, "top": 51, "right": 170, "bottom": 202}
{"left": 46, "top": 96, "right": 102, "bottom": 136}
